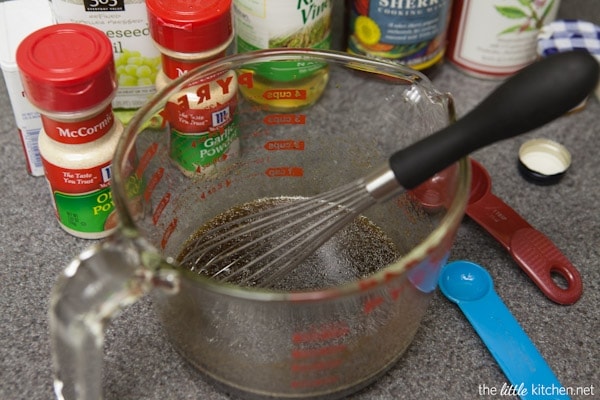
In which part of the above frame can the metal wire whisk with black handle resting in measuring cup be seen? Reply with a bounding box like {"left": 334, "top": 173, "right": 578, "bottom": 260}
{"left": 179, "top": 51, "right": 600, "bottom": 287}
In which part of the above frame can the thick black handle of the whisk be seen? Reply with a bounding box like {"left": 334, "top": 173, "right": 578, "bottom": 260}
{"left": 389, "top": 51, "right": 600, "bottom": 189}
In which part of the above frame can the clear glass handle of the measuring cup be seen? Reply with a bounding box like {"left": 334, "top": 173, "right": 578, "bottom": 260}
{"left": 49, "top": 231, "right": 177, "bottom": 400}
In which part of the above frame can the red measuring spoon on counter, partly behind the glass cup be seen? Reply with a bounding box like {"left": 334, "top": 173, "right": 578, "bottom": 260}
{"left": 411, "top": 159, "right": 583, "bottom": 304}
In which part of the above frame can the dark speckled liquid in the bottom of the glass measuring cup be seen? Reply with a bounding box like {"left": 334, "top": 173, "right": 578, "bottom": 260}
{"left": 177, "top": 197, "right": 400, "bottom": 291}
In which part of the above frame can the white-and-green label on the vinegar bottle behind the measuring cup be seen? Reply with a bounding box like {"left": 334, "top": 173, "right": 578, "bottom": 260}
{"left": 234, "top": 0, "right": 332, "bottom": 82}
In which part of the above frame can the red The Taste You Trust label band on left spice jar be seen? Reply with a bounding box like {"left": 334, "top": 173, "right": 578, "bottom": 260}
{"left": 42, "top": 157, "right": 111, "bottom": 194}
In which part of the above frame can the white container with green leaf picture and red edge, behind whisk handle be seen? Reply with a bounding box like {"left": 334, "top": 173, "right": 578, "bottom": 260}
{"left": 447, "top": 0, "right": 560, "bottom": 79}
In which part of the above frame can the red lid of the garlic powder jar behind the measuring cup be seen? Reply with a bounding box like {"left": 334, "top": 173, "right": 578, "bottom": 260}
{"left": 146, "top": 0, "right": 233, "bottom": 53}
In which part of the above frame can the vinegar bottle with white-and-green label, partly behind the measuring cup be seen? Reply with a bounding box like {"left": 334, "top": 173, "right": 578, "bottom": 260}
{"left": 234, "top": 0, "right": 332, "bottom": 111}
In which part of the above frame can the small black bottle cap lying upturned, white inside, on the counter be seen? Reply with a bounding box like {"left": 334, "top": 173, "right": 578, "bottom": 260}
{"left": 519, "top": 139, "right": 571, "bottom": 185}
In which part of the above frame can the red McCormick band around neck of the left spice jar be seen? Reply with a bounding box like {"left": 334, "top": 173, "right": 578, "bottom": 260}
{"left": 41, "top": 105, "right": 115, "bottom": 144}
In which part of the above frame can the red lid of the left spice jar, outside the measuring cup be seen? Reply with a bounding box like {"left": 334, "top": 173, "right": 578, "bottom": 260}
{"left": 17, "top": 24, "right": 117, "bottom": 112}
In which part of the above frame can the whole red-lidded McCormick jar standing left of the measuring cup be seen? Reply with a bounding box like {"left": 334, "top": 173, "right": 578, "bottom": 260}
{"left": 17, "top": 24, "right": 123, "bottom": 239}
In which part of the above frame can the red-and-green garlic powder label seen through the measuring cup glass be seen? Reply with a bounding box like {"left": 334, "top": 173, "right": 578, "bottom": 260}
{"left": 164, "top": 71, "right": 238, "bottom": 175}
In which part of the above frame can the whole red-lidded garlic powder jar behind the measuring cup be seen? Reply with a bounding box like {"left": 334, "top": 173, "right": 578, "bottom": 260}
{"left": 146, "top": 0, "right": 239, "bottom": 177}
